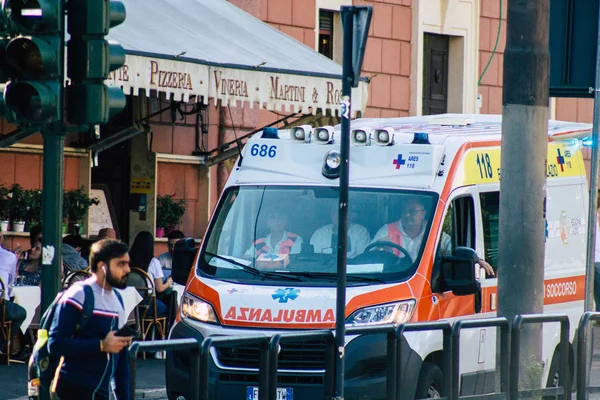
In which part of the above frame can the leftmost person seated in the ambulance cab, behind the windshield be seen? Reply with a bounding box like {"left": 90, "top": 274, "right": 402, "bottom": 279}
{"left": 244, "top": 209, "right": 302, "bottom": 257}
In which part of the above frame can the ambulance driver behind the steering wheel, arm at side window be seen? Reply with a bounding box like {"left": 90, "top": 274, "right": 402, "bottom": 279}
{"left": 372, "top": 197, "right": 452, "bottom": 261}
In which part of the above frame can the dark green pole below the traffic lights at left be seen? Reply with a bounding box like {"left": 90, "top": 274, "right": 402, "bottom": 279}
{"left": 41, "top": 124, "right": 66, "bottom": 313}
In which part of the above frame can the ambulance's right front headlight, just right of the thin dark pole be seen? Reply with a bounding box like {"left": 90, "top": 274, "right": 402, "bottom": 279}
{"left": 346, "top": 299, "right": 416, "bottom": 326}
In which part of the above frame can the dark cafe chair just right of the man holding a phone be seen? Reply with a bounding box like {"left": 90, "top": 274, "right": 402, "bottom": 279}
{"left": 127, "top": 268, "right": 167, "bottom": 358}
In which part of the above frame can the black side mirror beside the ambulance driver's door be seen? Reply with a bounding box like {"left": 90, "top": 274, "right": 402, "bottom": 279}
{"left": 442, "top": 246, "right": 481, "bottom": 296}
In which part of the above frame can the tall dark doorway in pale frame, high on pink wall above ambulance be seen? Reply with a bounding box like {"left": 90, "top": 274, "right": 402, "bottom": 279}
{"left": 423, "top": 33, "right": 450, "bottom": 115}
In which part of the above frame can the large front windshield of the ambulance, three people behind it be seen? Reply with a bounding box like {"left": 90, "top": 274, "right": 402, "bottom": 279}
{"left": 199, "top": 186, "right": 437, "bottom": 286}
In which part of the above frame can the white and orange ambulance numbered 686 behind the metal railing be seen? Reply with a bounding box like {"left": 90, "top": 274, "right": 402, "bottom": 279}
{"left": 166, "top": 114, "right": 592, "bottom": 400}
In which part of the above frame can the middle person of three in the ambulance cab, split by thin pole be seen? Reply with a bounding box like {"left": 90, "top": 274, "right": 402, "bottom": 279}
{"left": 310, "top": 201, "right": 371, "bottom": 258}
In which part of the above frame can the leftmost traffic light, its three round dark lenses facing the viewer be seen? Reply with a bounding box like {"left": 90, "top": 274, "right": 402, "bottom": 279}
{"left": 1, "top": 0, "right": 64, "bottom": 124}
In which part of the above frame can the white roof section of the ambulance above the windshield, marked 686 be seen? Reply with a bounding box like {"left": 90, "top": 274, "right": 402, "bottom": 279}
{"left": 234, "top": 114, "right": 592, "bottom": 190}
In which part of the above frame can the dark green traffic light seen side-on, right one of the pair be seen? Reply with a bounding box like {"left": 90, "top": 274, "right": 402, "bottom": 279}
{"left": 67, "top": 0, "right": 126, "bottom": 124}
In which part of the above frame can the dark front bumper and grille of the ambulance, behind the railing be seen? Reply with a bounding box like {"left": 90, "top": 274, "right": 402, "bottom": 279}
{"left": 165, "top": 321, "right": 422, "bottom": 400}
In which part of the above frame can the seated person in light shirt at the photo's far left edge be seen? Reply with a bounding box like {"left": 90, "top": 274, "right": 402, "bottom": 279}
{"left": 0, "top": 231, "right": 29, "bottom": 360}
